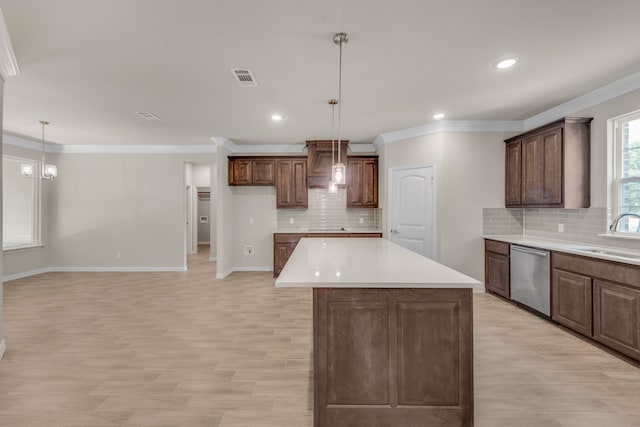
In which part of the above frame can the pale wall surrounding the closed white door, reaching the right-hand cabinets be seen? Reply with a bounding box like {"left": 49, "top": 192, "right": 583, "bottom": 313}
{"left": 379, "top": 132, "right": 511, "bottom": 281}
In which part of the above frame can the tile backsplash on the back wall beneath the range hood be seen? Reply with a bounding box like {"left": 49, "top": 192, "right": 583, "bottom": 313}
{"left": 277, "top": 188, "right": 380, "bottom": 230}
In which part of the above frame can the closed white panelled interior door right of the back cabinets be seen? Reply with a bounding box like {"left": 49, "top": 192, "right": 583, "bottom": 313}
{"left": 387, "top": 166, "right": 436, "bottom": 259}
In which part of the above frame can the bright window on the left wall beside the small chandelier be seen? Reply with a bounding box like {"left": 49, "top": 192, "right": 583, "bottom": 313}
{"left": 2, "top": 156, "right": 40, "bottom": 250}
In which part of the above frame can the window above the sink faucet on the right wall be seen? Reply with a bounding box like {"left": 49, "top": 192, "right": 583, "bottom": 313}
{"left": 611, "top": 108, "right": 640, "bottom": 232}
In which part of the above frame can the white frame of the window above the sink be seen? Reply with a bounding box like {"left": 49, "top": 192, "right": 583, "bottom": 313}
{"left": 608, "top": 110, "right": 640, "bottom": 237}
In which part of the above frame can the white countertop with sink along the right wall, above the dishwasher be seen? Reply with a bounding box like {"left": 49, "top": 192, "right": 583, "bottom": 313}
{"left": 483, "top": 235, "right": 640, "bottom": 265}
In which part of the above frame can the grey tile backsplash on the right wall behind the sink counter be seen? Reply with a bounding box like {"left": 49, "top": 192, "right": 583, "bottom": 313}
{"left": 482, "top": 207, "right": 640, "bottom": 250}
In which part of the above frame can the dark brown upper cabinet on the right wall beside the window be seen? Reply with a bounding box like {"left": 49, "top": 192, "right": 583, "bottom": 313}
{"left": 505, "top": 117, "right": 593, "bottom": 209}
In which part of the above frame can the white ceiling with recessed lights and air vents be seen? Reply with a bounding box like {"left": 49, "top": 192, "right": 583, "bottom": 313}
{"left": 0, "top": 0, "right": 640, "bottom": 145}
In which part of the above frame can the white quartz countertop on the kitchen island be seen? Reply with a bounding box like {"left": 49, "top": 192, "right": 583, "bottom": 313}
{"left": 276, "top": 237, "right": 484, "bottom": 292}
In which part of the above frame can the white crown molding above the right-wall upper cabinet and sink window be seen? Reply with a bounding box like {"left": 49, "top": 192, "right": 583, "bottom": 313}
{"left": 524, "top": 71, "right": 640, "bottom": 130}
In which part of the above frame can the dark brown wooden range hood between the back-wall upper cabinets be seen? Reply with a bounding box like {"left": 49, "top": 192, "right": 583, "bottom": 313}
{"left": 307, "top": 140, "right": 349, "bottom": 188}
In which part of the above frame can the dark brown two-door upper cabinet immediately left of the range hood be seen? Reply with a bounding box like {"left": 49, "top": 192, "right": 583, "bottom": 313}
{"left": 276, "top": 157, "right": 309, "bottom": 209}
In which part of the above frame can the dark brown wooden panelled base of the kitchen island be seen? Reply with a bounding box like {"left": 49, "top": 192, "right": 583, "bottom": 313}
{"left": 313, "top": 288, "right": 473, "bottom": 427}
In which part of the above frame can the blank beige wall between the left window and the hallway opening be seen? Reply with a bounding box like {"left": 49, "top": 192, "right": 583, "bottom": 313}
{"left": 49, "top": 154, "right": 214, "bottom": 270}
